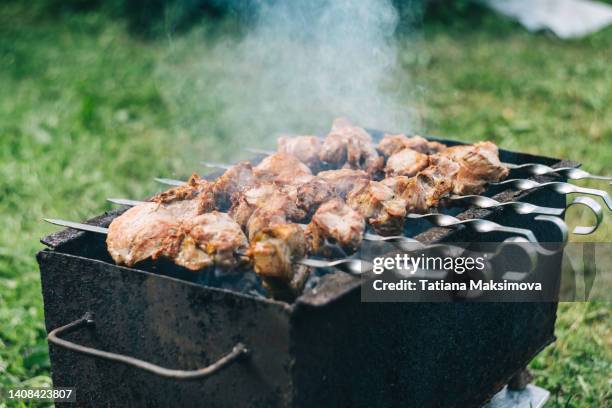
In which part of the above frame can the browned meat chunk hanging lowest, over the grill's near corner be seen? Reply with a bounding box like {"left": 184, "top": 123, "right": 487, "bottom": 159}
{"left": 248, "top": 223, "right": 310, "bottom": 300}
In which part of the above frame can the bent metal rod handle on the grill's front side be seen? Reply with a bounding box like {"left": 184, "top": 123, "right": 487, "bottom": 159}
{"left": 47, "top": 312, "right": 249, "bottom": 380}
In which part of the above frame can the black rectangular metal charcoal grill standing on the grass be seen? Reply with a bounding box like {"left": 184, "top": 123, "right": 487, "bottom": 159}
{"left": 37, "top": 132, "right": 600, "bottom": 407}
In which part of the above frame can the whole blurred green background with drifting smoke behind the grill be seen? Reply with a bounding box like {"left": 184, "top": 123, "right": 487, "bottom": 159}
{"left": 0, "top": 0, "right": 612, "bottom": 407}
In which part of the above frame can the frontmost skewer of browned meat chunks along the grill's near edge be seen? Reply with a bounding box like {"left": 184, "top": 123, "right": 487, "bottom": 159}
{"left": 53, "top": 169, "right": 556, "bottom": 299}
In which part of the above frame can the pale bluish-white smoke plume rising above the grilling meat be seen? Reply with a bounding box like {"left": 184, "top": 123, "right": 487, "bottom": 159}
{"left": 159, "top": 0, "right": 413, "bottom": 162}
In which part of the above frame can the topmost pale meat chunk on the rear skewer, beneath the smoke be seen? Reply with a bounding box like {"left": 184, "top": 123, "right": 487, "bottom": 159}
{"left": 319, "top": 118, "right": 384, "bottom": 177}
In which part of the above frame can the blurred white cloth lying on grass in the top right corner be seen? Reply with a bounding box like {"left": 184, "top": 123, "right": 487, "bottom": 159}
{"left": 484, "top": 0, "right": 612, "bottom": 39}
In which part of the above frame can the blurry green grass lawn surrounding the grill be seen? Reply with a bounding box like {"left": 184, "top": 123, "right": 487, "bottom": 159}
{"left": 0, "top": 3, "right": 612, "bottom": 407}
